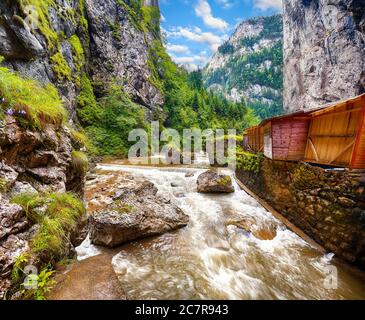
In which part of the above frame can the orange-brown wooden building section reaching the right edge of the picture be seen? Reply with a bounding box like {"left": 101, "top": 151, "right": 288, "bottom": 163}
{"left": 304, "top": 94, "right": 365, "bottom": 169}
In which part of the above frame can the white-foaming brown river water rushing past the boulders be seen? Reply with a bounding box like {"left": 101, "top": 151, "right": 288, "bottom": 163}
{"left": 78, "top": 165, "right": 365, "bottom": 299}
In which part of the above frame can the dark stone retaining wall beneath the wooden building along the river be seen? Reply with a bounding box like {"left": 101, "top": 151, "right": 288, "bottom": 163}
{"left": 236, "top": 158, "right": 365, "bottom": 268}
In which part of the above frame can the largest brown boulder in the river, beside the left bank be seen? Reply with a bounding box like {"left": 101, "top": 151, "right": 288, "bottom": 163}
{"left": 90, "top": 181, "right": 189, "bottom": 248}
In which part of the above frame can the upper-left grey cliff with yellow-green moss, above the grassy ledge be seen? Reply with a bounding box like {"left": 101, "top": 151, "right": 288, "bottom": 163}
{"left": 0, "top": 0, "right": 163, "bottom": 117}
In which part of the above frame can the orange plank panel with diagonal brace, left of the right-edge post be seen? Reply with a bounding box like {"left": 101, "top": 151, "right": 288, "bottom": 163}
{"left": 305, "top": 102, "right": 363, "bottom": 167}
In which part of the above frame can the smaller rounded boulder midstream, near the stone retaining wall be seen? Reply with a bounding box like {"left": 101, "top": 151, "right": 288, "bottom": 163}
{"left": 197, "top": 170, "right": 234, "bottom": 193}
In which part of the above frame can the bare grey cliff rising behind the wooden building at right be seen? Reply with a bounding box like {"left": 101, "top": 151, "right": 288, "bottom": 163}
{"left": 283, "top": 0, "right": 365, "bottom": 112}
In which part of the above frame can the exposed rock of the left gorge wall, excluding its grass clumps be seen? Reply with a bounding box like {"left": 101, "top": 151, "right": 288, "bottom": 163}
{"left": 0, "top": 0, "right": 163, "bottom": 299}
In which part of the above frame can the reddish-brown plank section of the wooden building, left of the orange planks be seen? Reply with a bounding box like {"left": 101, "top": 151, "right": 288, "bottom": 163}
{"left": 261, "top": 112, "right": 310, "bottom": 161}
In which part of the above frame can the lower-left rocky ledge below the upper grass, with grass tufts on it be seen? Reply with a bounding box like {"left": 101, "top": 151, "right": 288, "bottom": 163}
{"left": 0, "top": 116, "right": 87, "bottom": 299}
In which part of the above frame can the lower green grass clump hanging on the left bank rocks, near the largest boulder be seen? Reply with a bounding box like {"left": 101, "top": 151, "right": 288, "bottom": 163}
{"left": 11, "top": 193, "right": 86, "bottom": 300}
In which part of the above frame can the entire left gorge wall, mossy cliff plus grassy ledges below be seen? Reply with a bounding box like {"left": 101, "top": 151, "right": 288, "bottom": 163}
{"left": 0, "top": 0, "right": 163, "bottom": 299}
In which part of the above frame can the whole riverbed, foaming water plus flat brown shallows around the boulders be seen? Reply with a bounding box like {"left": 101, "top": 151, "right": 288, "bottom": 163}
{"left": 52, "top": 165, "right": 365, "bottom": 299}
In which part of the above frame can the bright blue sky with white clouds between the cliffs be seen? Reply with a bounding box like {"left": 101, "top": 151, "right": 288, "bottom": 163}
{"left": 160, "top": 0, "right": 282, "bottom": 70}
